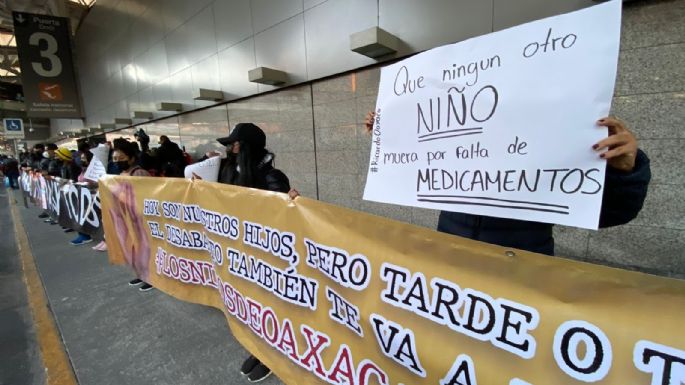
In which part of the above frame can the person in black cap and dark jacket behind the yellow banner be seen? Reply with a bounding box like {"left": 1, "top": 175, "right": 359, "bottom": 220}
{"left": 194, "top": 123, "right": 292, "bottom": 382}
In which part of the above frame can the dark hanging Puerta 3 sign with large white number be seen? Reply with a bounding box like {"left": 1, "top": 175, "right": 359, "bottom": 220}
{"left": 12, "top": 12, "right": 81, "bottom": 118}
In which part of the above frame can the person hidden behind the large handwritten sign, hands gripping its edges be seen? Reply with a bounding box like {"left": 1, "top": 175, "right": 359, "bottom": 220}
{"left": 365, "top": 111, "right": 651, "bottom": 255}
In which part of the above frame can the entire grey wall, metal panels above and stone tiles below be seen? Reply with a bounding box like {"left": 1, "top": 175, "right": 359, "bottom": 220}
{"left": 72, "top": 0, "right": 685, "bottom": 278}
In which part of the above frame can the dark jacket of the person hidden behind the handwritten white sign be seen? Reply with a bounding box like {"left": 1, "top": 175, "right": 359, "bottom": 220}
{"left": 438, "top": 150, "right": 651, "bottom": 255}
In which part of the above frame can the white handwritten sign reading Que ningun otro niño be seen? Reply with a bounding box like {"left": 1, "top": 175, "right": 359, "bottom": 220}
{"left": 364, "top": 0, "right": 621, "bottom": 229}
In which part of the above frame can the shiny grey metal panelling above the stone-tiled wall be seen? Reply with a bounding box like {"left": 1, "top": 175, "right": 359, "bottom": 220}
{"left": 76, "top": 0, "right": 604, "bottom": 127}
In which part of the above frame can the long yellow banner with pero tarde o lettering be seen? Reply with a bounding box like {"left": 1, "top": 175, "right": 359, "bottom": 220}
{"left": 100, "top": 177, "right": 685, "bottom": 385}
